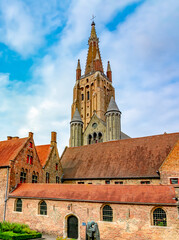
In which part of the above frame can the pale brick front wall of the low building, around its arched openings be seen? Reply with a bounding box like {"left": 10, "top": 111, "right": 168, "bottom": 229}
{"left": 5, "top": 198, "right": 179, "bottom": 240}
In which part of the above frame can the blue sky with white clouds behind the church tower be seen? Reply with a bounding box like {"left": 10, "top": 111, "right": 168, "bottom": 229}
{"left": 0, "top": 0, "right": 179, "bottom": 152}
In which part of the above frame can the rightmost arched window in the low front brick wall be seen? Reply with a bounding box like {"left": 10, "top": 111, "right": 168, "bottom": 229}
{"left": 153, "top": 208, "right": 167, "bottom": 226}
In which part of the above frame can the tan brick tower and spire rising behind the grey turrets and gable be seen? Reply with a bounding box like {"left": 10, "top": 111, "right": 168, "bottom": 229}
{"left": 71, "top": 22, "right": 114, "bottom": 131}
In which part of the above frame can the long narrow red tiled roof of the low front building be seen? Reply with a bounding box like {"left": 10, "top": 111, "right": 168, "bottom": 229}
{"left": 9, "top": 183, "right": 176, "bottom": 204}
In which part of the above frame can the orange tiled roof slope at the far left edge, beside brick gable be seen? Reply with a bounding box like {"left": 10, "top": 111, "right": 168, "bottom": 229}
{"left": 0, "top": 138, "right": 28, "bottom": 167}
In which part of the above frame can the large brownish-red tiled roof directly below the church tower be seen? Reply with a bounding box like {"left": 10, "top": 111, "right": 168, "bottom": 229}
{"left": 61, "top": 133, "right": 179, "bottom": 179}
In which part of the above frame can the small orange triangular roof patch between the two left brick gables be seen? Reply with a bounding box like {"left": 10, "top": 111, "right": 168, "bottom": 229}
{"left": 36, "top": 144, "right": 51, "bottom": 167}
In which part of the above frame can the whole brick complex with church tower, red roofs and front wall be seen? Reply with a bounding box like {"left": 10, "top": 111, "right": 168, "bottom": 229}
{"left": 0, "top": 22, "right": 179, "bottom": 240}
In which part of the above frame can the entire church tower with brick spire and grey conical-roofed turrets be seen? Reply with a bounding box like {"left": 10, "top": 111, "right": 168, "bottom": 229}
{"left": 70, "top": 21, "right": 129, "bottom": 147}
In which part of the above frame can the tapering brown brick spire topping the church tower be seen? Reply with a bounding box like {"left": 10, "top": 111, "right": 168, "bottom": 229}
{"left": 85, "top": 21, "right": 104, "bottom": 74}
